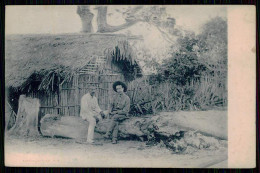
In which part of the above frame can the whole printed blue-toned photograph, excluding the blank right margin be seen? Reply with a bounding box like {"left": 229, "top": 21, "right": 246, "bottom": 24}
{"left": 4, "top": 5, "right": 255, "bottom": 168}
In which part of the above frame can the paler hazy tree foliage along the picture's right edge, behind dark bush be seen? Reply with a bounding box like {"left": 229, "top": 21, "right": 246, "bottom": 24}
{"left": 197, "top": 17, "right": 227, "bottom": 82}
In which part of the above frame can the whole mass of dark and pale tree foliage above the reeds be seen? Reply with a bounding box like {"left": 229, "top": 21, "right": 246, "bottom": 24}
{"left": 152, "top": 17, "right": 227, "bottom": 85}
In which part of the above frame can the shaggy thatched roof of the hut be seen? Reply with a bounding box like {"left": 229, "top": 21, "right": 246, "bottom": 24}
{"left": 5, "top": 34, "right": 140, "bottom": 89}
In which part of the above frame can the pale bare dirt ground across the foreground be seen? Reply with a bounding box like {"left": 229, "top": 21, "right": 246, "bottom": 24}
{"left": 5, "top": 110, "right": 228, "bottom": 168}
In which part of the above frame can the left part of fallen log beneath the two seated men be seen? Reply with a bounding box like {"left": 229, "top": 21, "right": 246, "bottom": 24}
{"left": 40, "top": 114, "right": 152, "bottom": 140}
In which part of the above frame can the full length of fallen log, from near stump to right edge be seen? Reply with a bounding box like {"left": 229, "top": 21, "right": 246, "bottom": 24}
{"left": 40, "top": 111, "right": 227, "bottom": 140}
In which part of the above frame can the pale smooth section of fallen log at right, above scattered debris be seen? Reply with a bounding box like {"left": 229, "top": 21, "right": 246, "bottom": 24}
{"left": 156, "top": 110, "right": 228, "bottom": 140}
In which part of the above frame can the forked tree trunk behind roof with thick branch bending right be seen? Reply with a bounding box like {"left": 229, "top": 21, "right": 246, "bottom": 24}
{"left": 97, "top": 6, "right": 140, "bottom": 33}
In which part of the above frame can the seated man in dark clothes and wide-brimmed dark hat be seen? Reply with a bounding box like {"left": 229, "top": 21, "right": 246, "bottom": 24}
{"left": 104, "top": 81, "right": 130, "bottom": 144}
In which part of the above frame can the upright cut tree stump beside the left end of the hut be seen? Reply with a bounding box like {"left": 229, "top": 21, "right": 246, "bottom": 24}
{"left": 8, "top": 95, "right": 40, "bottom": 136}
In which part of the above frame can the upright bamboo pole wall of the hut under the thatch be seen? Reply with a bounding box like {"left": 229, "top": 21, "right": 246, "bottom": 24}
{"left": 27, "top": 59, "right": 124, "bottom": 119}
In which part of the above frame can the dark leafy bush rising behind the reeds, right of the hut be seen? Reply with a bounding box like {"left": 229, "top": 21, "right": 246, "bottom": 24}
{"left": 154, "top": 33, "right": 207, "bottom": 86}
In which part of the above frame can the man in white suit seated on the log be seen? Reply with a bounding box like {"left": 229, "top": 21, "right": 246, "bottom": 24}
{"left": 80, "top": 88, "right": 104, "bottom": 144}
